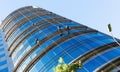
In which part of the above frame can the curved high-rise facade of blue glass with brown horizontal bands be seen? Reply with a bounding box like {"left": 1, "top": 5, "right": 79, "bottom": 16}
{"left": 2, "top": 6, "right": 120, "bottom": 72}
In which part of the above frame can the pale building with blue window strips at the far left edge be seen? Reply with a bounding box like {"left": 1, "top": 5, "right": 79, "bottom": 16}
{"left": 0, "top": 30, "right": 13, "bottom": 72}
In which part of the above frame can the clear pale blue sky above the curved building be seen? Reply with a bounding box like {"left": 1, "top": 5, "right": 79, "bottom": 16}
{"left": 0, "top": 0, "right": 120, "bottom": 38}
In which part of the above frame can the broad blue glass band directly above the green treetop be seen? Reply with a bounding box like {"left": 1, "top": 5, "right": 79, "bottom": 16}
{"left": 29, "top": 33, "right": 113, "bottom": 71}
